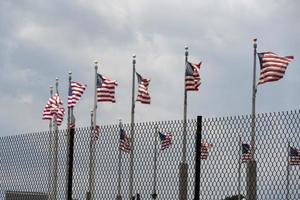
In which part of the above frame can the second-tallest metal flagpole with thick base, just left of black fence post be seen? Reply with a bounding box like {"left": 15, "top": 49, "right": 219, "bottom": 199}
{"left": 179, "top": 46, "right": 189, "bottom": 200}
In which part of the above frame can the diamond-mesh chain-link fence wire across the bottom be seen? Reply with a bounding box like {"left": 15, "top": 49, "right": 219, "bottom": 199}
{"left": 0, "top": 110, "right": 300, "bottom": 200}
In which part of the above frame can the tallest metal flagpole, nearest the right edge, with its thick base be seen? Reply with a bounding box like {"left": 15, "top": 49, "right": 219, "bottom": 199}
{"left": 247, "top": 38, "right": 257, "bottom": 200}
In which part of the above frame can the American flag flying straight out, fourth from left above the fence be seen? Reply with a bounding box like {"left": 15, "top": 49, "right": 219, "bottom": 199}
{"left": 97, "top": 74, "right": 118, "bottom": 103}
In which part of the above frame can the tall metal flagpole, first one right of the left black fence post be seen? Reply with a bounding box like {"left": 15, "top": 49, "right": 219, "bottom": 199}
{"left": 87, "top": 61, "right": 98, "bottom": 200}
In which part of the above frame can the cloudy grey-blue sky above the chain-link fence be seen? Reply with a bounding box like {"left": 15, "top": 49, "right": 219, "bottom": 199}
{"left": 0, "top": 0, "right": 300, "bottom": 136}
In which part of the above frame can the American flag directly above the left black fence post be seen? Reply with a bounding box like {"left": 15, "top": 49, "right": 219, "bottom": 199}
{"left": 68, "top": 81, "right": 87, "bottom": 108}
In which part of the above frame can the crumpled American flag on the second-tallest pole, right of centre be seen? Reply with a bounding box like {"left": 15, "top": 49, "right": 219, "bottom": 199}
{"left": 185, "top": 61, "right": 201, "bottom": 91}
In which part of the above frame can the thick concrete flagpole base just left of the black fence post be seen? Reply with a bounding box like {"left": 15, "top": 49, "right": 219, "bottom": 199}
{"left": 179, "top": 162, "right": 188, "bottom": 200}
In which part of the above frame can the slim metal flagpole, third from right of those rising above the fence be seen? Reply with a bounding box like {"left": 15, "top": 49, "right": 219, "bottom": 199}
{"left": 129, "top": 55, "right": 136, "bottom": 199}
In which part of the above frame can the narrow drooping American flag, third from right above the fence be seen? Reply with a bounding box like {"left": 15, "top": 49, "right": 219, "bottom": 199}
{"left": 136, "top": 73, "right": 151, "bottom": 104}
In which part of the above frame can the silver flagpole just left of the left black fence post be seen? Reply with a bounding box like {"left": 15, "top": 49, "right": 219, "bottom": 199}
{"left": 53, "top": 78, "right": 58, "bottom": 199}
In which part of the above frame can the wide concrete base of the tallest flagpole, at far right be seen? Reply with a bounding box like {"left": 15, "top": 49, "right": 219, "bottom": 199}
{"left": 247, "top": 160, "right": 257, "bottom": 200}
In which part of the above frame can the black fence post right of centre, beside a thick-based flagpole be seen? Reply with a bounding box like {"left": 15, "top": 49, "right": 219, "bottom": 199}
{"left": 194, "top": 116, "right": 202, "bottom": 200}
